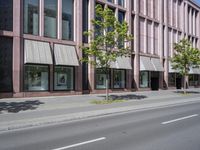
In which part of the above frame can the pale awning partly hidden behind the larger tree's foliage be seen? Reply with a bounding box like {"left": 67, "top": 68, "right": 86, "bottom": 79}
{"left": 110, "top": 56, "right": 132, "bottom": 70}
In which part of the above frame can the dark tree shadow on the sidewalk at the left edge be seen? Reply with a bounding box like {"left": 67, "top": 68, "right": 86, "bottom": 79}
{"left": 0, "top": 100, "right": 44, "bottom": 113}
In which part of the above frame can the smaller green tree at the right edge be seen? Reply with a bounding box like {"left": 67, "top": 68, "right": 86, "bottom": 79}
{"left": 171, "top": 39, "right": 200, "bottom": 93}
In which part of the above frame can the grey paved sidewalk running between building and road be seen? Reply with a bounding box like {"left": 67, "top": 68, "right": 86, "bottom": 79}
{"left": 0, "top": 89, "right": 200, "bottom": 131}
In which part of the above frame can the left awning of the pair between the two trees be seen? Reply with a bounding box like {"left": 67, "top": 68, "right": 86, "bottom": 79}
{"left": 140, "top": 56, "right": 156, "bottom": 71}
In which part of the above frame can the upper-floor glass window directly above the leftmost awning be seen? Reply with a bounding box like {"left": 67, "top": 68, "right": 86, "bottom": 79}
{"left": 24, "top": 0, "right": 39, "bottom": 35}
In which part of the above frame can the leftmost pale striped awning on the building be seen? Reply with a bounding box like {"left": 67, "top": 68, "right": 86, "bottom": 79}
{"left": 24, "top": 40, "right": 53, "bottom": 64}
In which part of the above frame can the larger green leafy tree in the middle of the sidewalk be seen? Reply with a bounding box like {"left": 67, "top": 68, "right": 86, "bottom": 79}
{"left": 81, "top": 4, "right": 132, "bottom": 100}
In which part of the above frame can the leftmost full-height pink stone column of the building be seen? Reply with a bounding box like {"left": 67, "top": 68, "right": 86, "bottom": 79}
{"left": 13, "top": 0, "right": 24, "bottom": 97}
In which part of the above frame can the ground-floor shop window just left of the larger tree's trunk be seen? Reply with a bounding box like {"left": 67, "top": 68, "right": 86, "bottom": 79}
{"left": 96, "top": 69, "right": 110, "bottom": 89}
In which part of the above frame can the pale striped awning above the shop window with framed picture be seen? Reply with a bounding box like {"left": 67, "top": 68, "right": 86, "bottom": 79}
{"left": 54, "top": 44, "right": 79, "bottom": 66}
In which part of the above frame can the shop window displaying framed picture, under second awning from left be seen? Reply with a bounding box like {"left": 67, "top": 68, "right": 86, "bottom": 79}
{"left": 54, "top": 66, "right": 74, "bottom": 90}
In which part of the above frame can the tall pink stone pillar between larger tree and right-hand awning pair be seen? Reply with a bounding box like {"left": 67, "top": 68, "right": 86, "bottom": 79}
{"left": 134, "top": 0, "right": 142, "bottom": 90}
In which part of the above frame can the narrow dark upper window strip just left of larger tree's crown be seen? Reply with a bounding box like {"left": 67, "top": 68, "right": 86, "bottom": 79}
{"left": 83, "top": 0, "right": 89, "bottom": 43}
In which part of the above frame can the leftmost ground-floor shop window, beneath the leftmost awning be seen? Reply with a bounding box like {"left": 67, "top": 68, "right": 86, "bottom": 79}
{"left": 25, "top": 65, "right": 49, "bottom": 91}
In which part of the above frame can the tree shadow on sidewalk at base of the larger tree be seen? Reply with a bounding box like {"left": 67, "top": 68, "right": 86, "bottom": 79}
{"left": 100, "top": 94, "right": 147, "bottom": 100}
